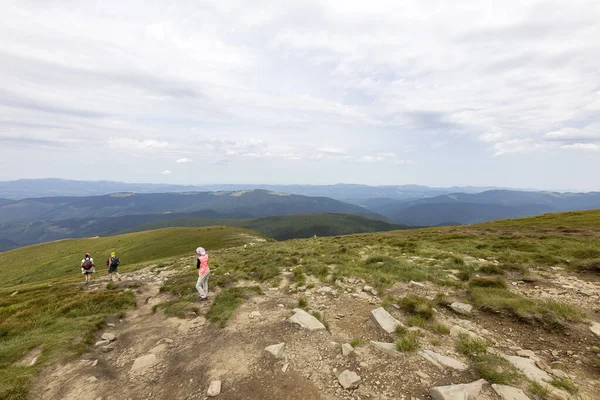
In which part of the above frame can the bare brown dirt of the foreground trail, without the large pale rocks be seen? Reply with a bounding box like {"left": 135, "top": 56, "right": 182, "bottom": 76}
{"left": 31, "top": 270, "right": 599, "bottom": 400}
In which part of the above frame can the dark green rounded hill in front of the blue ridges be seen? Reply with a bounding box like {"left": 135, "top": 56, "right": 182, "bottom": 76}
{"left": 126, "top": 214, "right": 407, "bottom": 240}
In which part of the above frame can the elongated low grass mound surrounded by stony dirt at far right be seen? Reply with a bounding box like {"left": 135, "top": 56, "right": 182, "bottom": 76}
{"left": 470, "top": 287, "right": 586, "bottom": 328}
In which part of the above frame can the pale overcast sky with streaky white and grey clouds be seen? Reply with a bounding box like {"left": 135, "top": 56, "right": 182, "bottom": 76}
{"left": 0, "top": 0, "right": 600, "bottom": 190}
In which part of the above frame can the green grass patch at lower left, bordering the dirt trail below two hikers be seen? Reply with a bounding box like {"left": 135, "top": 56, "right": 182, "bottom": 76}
{"left": 0, "top": 283, "right": 135, "bottom": 400}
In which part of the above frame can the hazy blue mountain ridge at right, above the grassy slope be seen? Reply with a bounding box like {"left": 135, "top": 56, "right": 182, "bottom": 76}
{"left": 371, "top": 190, "right": 600, "bottom": 226}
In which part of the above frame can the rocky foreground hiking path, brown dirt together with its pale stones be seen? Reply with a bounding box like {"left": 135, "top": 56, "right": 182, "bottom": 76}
{"left": 31, "top": 264, "right": 600, "bottom": 400}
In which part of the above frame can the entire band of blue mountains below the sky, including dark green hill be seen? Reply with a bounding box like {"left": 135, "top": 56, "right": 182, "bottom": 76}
{"left": 0, "top": 180, "right": 600, "bottom": 251}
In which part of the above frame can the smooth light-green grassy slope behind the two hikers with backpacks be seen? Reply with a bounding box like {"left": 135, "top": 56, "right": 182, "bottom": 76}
{"left": 0, "top": 226, "right": 258, "bottom": 287}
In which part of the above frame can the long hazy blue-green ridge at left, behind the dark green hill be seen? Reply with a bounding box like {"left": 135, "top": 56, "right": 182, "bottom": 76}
{"left": 0, "top": 190, "right": 381, "bottom": 223}
